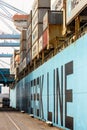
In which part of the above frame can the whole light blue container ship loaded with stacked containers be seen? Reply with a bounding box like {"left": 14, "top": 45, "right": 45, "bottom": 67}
{"left": 10, "top": 0, "right": 87, "bottom": 130}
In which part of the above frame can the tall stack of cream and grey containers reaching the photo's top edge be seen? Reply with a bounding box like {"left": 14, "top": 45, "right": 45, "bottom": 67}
{"left": 32, "top": 0, "right": 50, "bottom": 60}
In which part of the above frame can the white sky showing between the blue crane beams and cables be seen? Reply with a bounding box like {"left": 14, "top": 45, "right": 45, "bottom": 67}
{"left": 0, "top": 0, "right": 34, "bottom": 68}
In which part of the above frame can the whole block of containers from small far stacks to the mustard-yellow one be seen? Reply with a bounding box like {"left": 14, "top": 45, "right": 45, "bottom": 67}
{"left": 20, "top": 0, "right": 63, "bottom": 71}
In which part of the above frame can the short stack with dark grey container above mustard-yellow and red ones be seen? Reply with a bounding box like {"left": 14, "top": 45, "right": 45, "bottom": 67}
{"left": 43, "top": 10, "right": 63, "bottom": 49}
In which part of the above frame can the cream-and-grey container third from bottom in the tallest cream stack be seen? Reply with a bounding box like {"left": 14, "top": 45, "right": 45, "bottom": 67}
{"left": 32, "top": 8, "right": 49, "bottom": 30}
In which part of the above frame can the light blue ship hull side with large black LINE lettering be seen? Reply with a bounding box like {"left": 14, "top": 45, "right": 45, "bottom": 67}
{"left": 12, "top": 34, "right": 87, "bottom": 130}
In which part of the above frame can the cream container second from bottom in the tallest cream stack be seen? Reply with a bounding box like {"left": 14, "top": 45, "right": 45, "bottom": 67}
{"left": 32, "top": 24, "right": 43, "bottom": 44}
